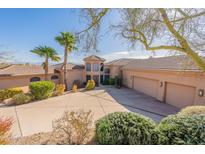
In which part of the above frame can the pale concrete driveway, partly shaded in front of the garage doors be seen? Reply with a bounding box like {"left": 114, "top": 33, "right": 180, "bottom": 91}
{"left": 0, "top": 87, "right": 178, "bottom": 137}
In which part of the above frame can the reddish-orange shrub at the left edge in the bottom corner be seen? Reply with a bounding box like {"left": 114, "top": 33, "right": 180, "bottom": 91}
{"left": 0, "top": 117, "right": 13, "bottom": 145}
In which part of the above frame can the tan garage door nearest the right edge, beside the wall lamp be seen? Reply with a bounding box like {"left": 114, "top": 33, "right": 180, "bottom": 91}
{"left": 165, "top": 82, "right": 196, "bottom": 108}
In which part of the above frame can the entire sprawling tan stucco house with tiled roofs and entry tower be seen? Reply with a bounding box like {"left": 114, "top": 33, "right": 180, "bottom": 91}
{"left": 0, "top": 55, "right": 205, "bottom": 108}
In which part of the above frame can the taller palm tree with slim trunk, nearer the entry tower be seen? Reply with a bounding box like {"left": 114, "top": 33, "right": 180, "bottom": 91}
{"left": 55, "top": 32, "right": 77, "bottom": 90}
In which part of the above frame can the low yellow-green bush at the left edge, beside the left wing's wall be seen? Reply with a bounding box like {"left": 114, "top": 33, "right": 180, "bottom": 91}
{"left": 0, "top": 88, "right": 23, "bottom": 101}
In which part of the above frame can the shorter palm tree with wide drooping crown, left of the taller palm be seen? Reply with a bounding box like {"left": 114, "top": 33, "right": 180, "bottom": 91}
{"left": 31, "top": 46, "right": 60, "bottom": 80}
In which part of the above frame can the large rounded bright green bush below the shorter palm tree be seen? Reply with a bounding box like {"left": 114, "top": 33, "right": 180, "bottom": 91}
{"left": 29, "top": 81, "right": 55, "bottom": 100}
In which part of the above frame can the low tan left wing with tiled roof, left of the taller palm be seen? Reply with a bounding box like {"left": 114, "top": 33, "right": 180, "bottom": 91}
{"left": 0, "top": 65, "right": 59, "bottom": 89}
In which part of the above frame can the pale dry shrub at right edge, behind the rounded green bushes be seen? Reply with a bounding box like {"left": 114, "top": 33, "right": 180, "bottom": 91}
{"left": 179, "top": 106, "right": 205, "bottom": 115}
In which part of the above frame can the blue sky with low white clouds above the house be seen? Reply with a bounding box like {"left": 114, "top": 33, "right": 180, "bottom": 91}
{"left": 0, "top": 9, "right": 167, "bottom": 63}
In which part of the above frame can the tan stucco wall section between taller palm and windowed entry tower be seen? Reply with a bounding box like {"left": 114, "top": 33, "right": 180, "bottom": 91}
{"left": 67, "top": 69, "right": 83, "bottom": 90}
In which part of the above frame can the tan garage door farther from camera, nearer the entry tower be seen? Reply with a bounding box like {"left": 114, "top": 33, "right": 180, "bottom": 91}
{"left": 134, "top": 77, "right": 158, "bottom": 98}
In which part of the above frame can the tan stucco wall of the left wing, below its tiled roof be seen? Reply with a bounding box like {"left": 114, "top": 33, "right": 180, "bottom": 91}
{"left": 0, "top": 74, "right": 59, "bottom": 89}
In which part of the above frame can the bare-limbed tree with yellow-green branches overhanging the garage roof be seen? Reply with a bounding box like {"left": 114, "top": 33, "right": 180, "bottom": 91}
{"left": 76, "top": 8, "right": 205, "bottom": 72}
